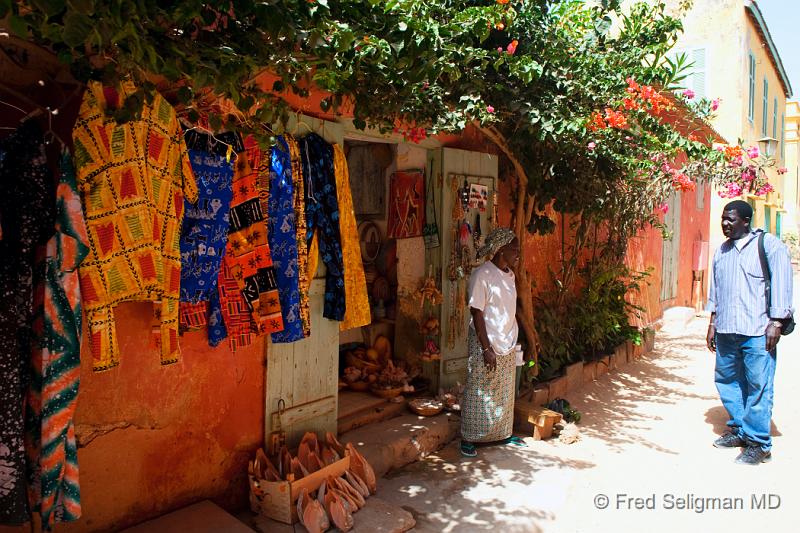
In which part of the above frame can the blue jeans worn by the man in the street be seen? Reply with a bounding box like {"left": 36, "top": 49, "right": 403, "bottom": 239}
{"left": 714, "top": 333, "right": 776, "bottom": 451}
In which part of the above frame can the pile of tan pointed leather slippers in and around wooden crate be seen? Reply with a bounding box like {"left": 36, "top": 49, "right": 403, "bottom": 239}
{"left": 249, "top": 432, "right": 377, "bottom": 533}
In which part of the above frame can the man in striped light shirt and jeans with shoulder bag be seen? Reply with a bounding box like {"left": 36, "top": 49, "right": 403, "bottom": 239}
{"left": 706, "top": 200, "right": 793, "bottom": 465}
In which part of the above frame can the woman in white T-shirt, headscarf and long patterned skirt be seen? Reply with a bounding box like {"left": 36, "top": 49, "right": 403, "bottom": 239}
{"left": 461, "top": 228, "right": 524, "bottom": 457}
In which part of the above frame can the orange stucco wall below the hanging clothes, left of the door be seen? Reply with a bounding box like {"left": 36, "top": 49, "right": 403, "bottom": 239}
{"left": 59, "top": 303, "right": 265, "bottom": 532}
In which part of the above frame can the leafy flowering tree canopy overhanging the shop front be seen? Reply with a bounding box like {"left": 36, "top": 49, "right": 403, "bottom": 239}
{"left": 0, "top": 0, "right": 772, "bottom": 374}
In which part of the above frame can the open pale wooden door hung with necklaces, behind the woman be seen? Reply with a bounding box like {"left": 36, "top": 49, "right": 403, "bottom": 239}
{"left": 430, "top": 148, "right": 498, "bottom": 387}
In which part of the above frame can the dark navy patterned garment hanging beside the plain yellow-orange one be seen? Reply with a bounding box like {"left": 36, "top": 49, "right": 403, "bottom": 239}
{"left": 299, "top": 133, "right": 345, "bottom": 321}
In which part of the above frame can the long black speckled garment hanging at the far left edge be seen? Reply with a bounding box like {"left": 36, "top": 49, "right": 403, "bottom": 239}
{"left": 0, "top": 121, "right": 55, "bottom": 525}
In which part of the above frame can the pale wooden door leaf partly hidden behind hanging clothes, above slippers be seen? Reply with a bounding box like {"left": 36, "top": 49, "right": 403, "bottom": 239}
{"left": 264, "top": 115, "right": 344, "bottom": 447}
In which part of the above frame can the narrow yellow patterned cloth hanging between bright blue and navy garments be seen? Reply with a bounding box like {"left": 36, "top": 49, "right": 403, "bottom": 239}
{"left": 285, "top": 135, "right": 317, "bottom": 338}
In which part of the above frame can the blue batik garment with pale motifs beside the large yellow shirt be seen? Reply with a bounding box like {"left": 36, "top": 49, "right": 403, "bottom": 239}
{"left": 180, "top": 149, "right": 233, "bottom": 346}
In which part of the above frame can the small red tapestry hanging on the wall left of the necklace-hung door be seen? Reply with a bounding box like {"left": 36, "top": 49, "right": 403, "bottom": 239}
{"left": 387, "top": 170, "right": 425, "bottom": 239}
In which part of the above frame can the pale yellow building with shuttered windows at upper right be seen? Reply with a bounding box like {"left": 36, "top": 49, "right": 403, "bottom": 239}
{"left": 667, "top": 0, "right": 797, "bottom": 245}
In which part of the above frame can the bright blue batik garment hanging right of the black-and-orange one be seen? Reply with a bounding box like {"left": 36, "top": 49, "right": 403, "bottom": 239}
{"left": 267, "top": 137, "right": 304, "bottom": 343}
